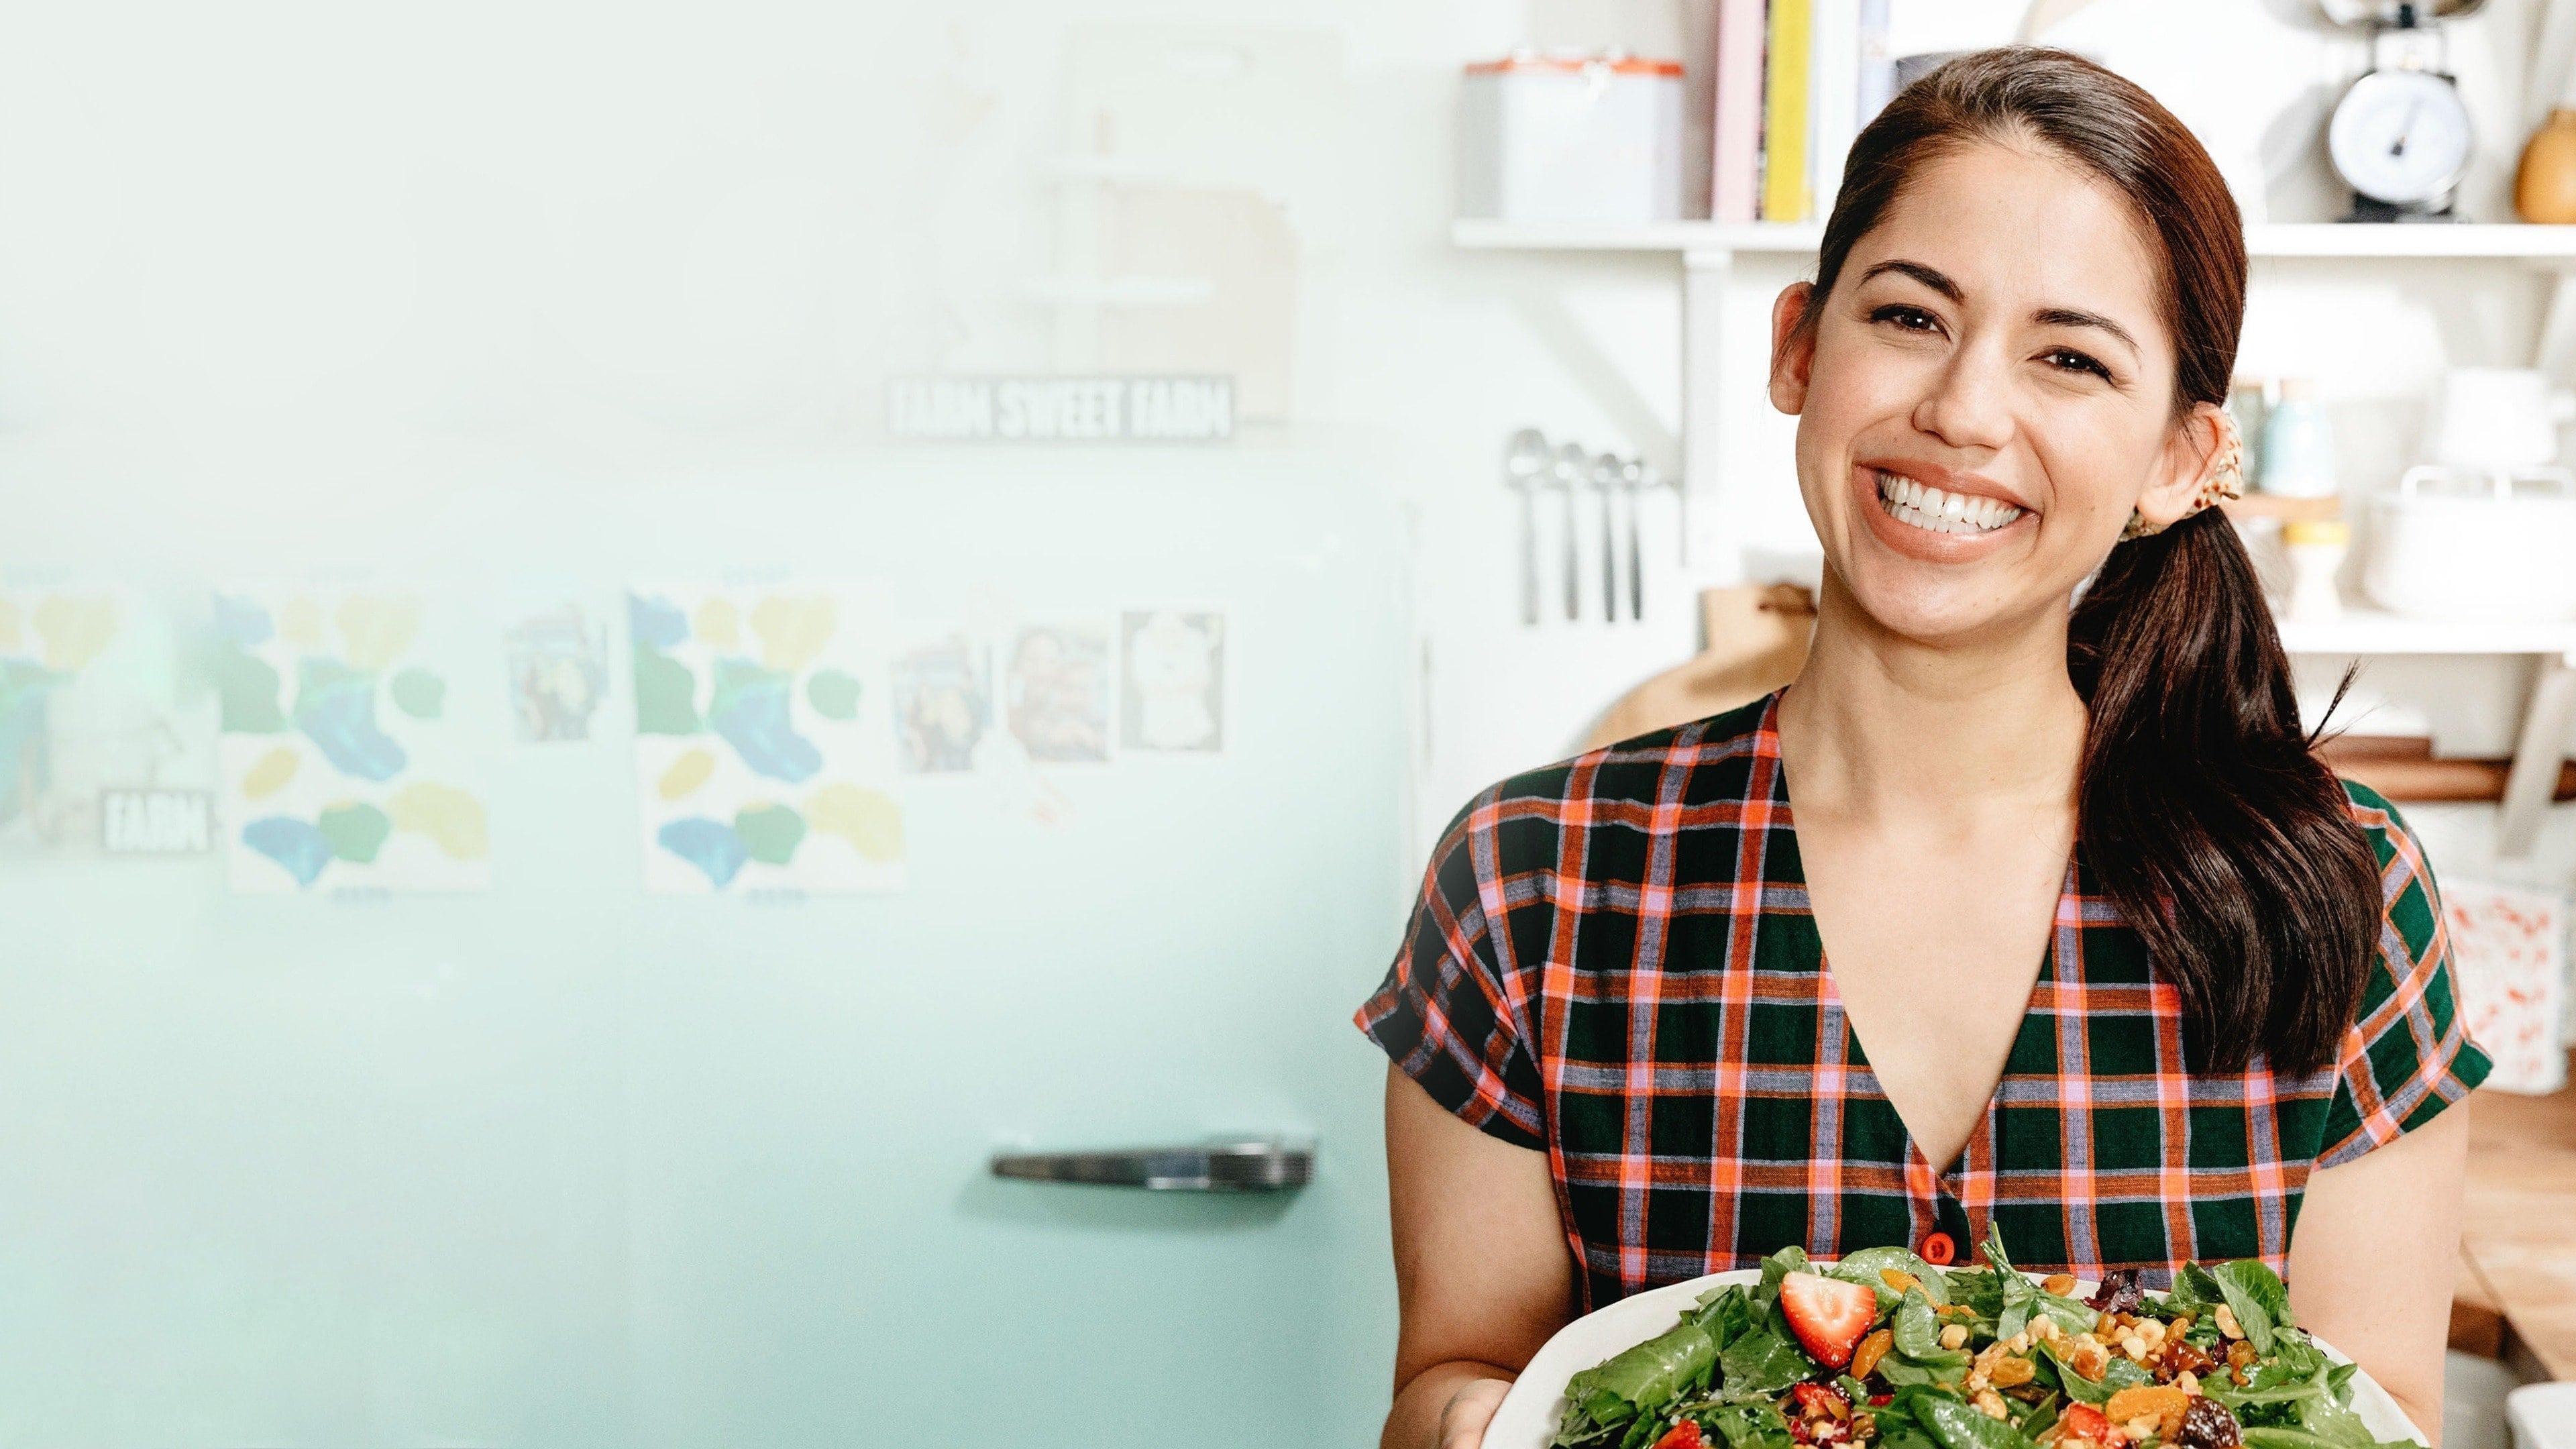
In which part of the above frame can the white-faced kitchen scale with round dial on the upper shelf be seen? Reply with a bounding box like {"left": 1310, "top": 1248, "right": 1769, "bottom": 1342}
{"left": 2318, "top": 0, "right": 2486, "bottom": 222}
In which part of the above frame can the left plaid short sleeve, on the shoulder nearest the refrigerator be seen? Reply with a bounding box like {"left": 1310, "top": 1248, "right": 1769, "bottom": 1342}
{"left": 1355, "top": 792, "right": 1548, "bottom": 1147}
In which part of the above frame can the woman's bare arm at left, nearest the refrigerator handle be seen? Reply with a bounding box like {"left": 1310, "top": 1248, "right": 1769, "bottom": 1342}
{"left": 1378, "top": 1067, "right": 1574, "bottom": 1449}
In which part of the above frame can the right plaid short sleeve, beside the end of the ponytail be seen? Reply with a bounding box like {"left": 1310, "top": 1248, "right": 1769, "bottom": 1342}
{"left": 2316, "top": 782, "right": 2491, "bottom": 1168}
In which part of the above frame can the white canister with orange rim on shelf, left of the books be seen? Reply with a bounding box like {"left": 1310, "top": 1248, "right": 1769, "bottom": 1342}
{"left": 1458, "top": 52, "right": 1682, "bottom": 222}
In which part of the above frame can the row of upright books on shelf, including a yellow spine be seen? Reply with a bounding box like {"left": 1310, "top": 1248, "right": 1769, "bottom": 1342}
{"left": 1708, "top": 0, "right": 1896, "bottom": 222}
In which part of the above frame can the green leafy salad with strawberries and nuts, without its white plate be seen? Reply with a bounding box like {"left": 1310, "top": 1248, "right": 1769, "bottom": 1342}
{"left": 1554, "top": 1217, "right": 2404, "bottom": 1449}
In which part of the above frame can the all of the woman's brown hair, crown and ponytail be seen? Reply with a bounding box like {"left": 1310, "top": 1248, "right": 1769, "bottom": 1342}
{"left": 1798, "top": 46, "right": 2380, "bottom": 1073}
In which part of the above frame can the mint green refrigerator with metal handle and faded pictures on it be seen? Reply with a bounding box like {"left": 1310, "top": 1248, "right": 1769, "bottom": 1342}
{"left": 0, "top": 446, "right": 1411, "bottom": 1449}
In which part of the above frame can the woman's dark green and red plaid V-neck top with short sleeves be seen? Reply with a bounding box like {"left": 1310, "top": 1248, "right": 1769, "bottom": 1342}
{"left": 1358, "top": 694, "right": 2488, "bottom": 1307}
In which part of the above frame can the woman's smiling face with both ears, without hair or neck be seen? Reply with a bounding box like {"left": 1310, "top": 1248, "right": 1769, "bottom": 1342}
{"left": 1772, "top": 144, "right": 2218, "bottom": 642}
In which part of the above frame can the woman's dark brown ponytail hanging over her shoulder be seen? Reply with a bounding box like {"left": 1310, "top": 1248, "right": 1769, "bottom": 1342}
{"left": 2066, "top": 508, "right": 2380, "bottom": 1073}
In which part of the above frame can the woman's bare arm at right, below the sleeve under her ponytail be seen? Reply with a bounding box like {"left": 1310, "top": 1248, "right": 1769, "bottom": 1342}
{"left": 2290, "top": 1101, "right": 2468, "bottom": 1449}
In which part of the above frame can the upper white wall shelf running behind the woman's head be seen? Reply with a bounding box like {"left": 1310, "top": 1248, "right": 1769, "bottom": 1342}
{"left": 1450, "top": 222, "right": 2576, "bottom": 263}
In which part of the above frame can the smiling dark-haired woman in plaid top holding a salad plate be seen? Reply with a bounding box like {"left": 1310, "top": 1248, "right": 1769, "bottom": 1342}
{"left": 1360, "top": 46, "right": 2486, "bottom": 1446}
